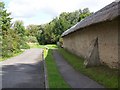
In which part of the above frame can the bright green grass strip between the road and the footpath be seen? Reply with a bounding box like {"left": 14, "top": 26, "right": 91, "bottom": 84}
{"left": 44, "top": 45, "right": 70, "bottom": 88}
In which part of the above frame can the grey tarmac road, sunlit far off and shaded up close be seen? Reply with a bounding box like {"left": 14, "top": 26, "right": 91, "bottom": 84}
{"left": 0, "top": 48, "right": 44, "bottom": 88}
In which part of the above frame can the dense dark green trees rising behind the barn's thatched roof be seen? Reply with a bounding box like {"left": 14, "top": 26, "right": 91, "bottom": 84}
{"left": 36, "top": 8, "right": 92, "bottom": 45}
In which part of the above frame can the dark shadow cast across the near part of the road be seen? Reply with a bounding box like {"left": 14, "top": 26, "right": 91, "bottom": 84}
{"left": 2, "top": 61, "right": 44, "bottom": 88}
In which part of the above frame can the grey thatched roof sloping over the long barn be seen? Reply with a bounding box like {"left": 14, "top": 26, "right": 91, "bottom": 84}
{"left": 62, "top": 0, "right": 120, "bottom": 37}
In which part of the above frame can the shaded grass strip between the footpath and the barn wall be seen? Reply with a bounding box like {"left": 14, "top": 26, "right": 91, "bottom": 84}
{"left": 58, "top": 48, "right": 118, "bottom": 88}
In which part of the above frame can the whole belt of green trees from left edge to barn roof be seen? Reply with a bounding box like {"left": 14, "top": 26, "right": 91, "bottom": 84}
{"left": 0, "top": 2, "right": 92, "bottom": 57}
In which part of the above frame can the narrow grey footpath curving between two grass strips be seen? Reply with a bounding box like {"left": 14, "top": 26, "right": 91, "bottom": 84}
{"left": 53, "top": 50, "right": 104, "bottom": 88}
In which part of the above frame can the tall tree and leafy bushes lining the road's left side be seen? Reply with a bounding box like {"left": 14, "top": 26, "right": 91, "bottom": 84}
{"left": 0, "top": 2, "right": 29, "bottom": 58}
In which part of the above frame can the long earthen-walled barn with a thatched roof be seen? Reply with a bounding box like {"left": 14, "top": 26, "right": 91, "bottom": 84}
{"left": 62, "top": 0, "right": 120, "bottom": 68}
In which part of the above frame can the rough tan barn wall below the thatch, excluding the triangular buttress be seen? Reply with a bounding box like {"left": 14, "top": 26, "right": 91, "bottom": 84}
{"left": 63, "top": 19, "right": 118, "bottom": 68}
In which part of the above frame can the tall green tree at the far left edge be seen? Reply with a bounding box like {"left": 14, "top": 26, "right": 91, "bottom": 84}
{"left": 0, "top": 2, "right": 13, "bottom": 57}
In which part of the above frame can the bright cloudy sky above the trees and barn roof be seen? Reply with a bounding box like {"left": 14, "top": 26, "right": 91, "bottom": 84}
{"left": 0, "top": 0, "right": 114, "bottom": 26}
